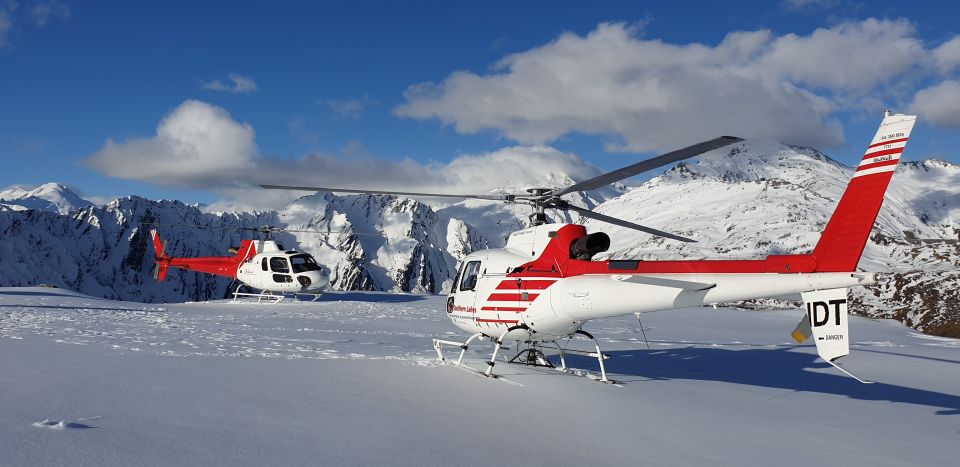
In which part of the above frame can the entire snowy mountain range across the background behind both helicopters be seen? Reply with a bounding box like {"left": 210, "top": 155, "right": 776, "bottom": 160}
{"left": 0, "top": 142, "right": 960, "bottom": 335}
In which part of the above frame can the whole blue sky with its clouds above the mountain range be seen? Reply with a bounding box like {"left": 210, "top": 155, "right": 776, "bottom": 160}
{"left": 0, "top": 0, "right": 960, "bottom": 207}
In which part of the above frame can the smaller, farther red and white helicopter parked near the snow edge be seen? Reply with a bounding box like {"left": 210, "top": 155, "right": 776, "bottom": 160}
{"left": 150, "top": 227, "right": 330, "bottom": 303}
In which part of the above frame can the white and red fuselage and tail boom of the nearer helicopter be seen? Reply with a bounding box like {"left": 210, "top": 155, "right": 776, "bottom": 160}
{"left": 447, "top": 224, "right": 876, "bottom": 342}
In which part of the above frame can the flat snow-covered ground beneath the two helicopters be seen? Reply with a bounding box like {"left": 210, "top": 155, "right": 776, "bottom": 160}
{"left": 0, "top": 288, "right": 960, "bottom": 466}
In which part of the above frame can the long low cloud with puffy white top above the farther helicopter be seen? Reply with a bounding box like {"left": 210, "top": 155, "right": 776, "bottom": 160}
{"left": 85, "top": 100, "right": 599, "bottom": 208}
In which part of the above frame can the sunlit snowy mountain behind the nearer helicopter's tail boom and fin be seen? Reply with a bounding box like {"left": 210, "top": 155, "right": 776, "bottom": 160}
{"left": 587, "top": 142, "right": 960, "bottom": 336}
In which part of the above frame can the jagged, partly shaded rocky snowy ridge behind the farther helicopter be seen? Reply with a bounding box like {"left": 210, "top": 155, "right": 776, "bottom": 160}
{"left": 0, "top": 194, "right": 485, "bottom": 302}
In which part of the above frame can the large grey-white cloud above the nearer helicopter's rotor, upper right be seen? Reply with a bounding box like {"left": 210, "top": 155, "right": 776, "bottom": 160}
{"left": 394, "top": 19, "right": 932, "bottom": 151}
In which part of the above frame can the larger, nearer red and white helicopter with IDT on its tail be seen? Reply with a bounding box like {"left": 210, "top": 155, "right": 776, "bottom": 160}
{"left": 261, "top": 111, "right": 916, "bottom": 382}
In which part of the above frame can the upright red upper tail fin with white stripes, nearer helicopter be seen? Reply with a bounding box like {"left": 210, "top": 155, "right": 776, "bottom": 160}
{"left": 813, "top": 111, "right": 917, "bottom": 272}
